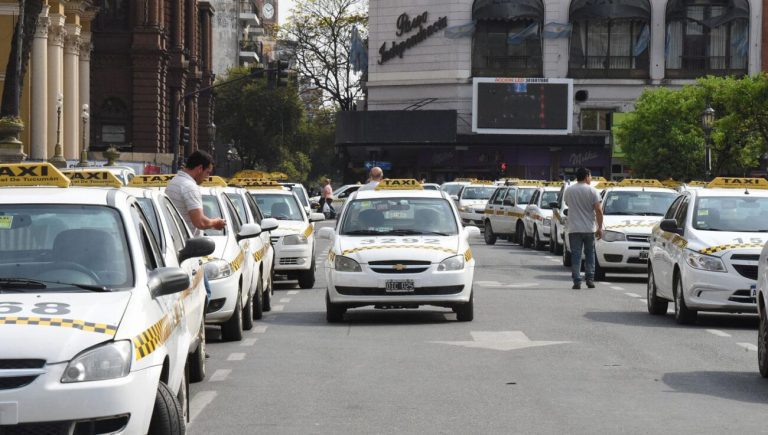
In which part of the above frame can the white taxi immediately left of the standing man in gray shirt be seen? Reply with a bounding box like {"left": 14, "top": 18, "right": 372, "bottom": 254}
{"left": 522, "top": 181, "right": 563, "bottom": 249}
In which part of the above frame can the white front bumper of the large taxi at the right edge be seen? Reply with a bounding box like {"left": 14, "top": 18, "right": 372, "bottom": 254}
{"left": 682, "top": 264, "right": 757, "bottom": 313}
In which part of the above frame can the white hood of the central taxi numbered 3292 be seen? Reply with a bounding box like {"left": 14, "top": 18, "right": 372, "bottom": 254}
{"left": 336, "top": 236, "right": 459, "bottom": 263}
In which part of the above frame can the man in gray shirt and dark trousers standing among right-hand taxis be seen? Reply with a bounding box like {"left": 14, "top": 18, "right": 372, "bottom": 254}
{"left": 563, "top": 168, "right": 603, "bottom": 290}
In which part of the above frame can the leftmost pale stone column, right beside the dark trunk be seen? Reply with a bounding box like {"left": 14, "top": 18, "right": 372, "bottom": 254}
{"left": 29, "top": 6, "right": 55, "bottom": 160}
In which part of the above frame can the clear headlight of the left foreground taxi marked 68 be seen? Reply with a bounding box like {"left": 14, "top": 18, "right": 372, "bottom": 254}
{"left": 61, "top": 340, "right": 132, "bottom": 383}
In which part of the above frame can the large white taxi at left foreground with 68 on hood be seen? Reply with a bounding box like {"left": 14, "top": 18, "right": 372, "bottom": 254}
{"left": 0, "top": 163, "right": 211, "bottom": 434}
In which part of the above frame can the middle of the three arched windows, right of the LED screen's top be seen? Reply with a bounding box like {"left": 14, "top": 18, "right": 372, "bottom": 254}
{"left": 568, "top": 0, "right": 651, "bottom": 78}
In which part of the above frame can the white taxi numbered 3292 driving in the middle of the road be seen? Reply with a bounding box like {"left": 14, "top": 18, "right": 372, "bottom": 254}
{"left": 319, "top": 179, "right": 480, "bottom": 322}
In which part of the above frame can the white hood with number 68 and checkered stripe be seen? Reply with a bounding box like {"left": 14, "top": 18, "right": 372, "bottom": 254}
{"left": 0, "top": 291, "right": 131, "bottom": 364}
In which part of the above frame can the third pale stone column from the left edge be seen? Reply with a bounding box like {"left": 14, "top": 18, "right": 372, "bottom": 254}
{"left": 62, "top": 23, "right": 80, "bottom": 160}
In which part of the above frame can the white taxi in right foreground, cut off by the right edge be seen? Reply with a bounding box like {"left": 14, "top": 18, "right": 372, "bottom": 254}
{"left": 648, "top": 177, "right": 768, "bottom": 323}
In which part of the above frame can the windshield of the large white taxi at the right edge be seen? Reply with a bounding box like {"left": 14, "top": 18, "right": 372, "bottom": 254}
{"left": 693, "top": 195, "right": 768, "bottom": 232}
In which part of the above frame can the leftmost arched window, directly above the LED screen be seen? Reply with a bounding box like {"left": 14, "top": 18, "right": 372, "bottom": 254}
{"left": 472, "top": 0, "right": 544, "bottom": 77}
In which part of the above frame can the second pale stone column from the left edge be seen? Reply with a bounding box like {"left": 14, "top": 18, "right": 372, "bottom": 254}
{"left": 47, "top": 14, "right": 67, "bottom": 160}
